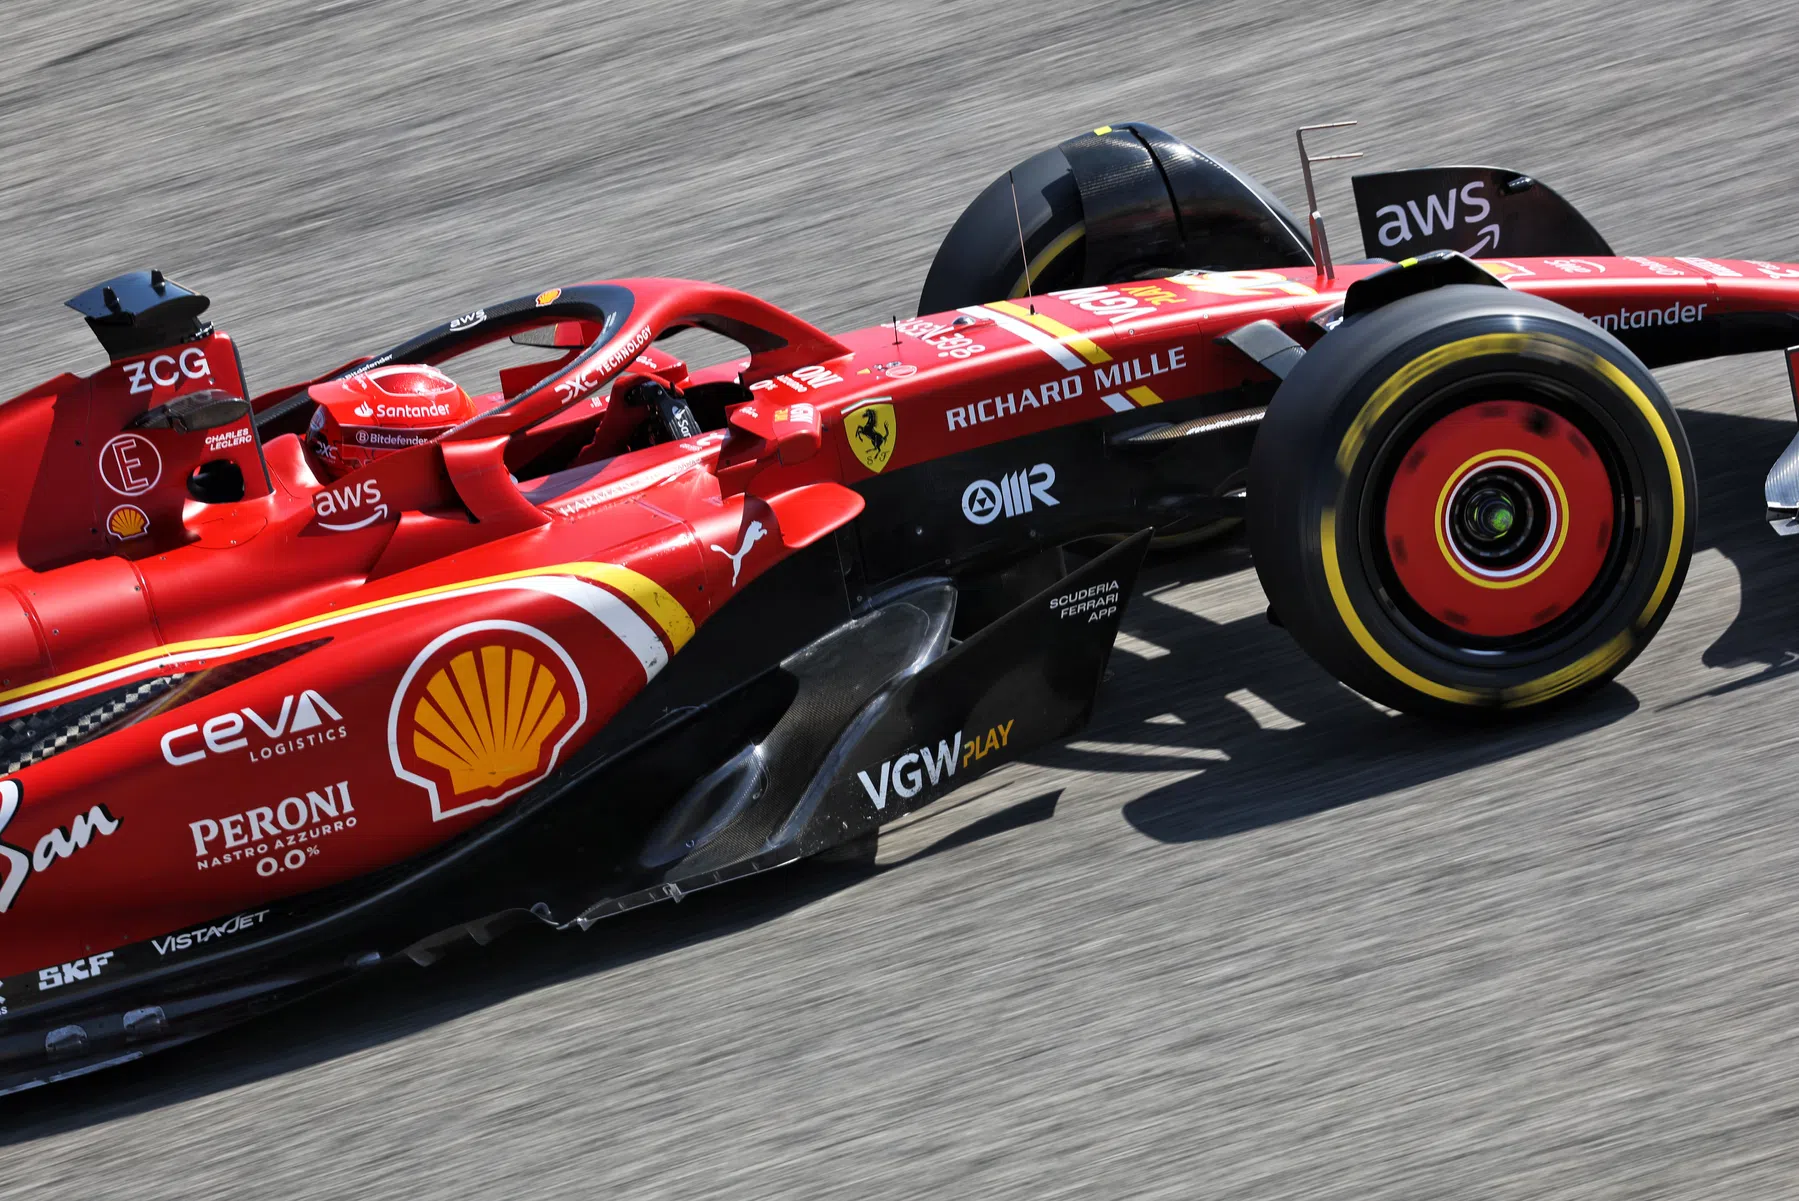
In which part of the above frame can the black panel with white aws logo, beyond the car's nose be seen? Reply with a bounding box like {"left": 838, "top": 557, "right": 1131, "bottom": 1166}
{"left": 1351, "top": 167, "right": 1612, "bottom": 259}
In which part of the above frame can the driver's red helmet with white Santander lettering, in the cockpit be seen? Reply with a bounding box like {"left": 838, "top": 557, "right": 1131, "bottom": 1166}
{"left": 306, "top": 363, "right": 475, "bottom": 478}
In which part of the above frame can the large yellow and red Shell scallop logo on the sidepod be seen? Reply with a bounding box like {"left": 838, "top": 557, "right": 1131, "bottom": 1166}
{"left": 387, "top": 620, "right": 586, "bottom": 822}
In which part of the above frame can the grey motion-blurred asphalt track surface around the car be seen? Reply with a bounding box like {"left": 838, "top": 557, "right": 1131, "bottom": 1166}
{"left": 0, "top": 0, "right": 1799, "bottom": 1201}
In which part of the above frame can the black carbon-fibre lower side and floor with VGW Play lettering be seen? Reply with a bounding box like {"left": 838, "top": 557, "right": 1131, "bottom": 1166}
{"left": 0, "top": 532, "right": 1148, "bottom": 1095}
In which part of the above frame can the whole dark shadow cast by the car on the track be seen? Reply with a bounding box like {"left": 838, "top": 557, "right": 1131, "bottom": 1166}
{"left": 0, "top": 412, "right": 1799, "bottom": 1145}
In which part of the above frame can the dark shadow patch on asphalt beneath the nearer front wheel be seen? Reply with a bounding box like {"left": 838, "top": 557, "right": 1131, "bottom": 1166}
{"left": 1033, "top": 545, "right": 1637, "bottom": 841}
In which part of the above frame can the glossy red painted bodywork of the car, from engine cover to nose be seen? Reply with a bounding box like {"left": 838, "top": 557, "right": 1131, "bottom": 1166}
{"left": 0, "top": 257, "right": 1799, "bottom": 976}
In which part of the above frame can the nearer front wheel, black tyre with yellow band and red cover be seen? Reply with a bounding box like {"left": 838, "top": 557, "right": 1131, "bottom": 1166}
{"left": 1249, "top": 286, "right": 1695, "bottom": 717}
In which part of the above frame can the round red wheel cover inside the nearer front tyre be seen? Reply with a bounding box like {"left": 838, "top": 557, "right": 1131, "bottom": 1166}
{"left": 1383, "top": 401, "right": 1617, "bottom": 638}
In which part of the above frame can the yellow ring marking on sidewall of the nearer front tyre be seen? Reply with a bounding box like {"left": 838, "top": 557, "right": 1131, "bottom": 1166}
{"left": 1319, "top": 333, "right": 1687, "bottom": 708}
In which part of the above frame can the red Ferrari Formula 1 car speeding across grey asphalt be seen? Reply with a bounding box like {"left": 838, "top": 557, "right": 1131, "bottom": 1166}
{"left": 0, "top": 124, "right": 1799, "bottom": 1090}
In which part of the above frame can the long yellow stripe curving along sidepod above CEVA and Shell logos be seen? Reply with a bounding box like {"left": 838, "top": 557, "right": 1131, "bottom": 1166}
{"left": 0, "top": 563, "right": 694, "bottom": 705}
